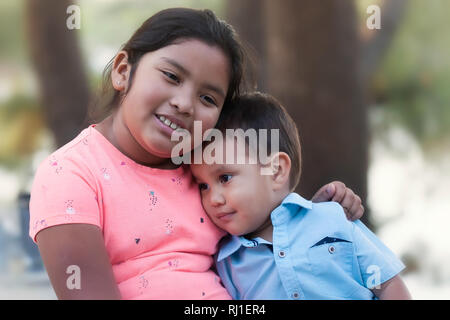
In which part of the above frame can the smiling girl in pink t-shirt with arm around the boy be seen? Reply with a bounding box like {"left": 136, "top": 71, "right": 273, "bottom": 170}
{"left": 30, "top": 9, "right": 363, "bottom": 299}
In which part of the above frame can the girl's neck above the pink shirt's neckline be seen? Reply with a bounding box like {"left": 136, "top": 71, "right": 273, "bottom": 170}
{"left": 95, "top": 114, "right": 178, "bottom": 169}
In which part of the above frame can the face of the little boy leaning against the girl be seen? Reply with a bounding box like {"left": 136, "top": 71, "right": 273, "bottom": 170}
{"left": 191, "top": 138, "right": 277, "bottom": 236}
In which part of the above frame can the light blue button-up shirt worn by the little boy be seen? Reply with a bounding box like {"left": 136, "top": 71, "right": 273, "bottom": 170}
{"left": 216, "top": 193, "right": 405, "bottom": 300}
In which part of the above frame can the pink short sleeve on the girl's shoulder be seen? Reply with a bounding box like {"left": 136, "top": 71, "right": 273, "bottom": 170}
{"left": 29, "top": 154, "right": 102, "bottom": 242}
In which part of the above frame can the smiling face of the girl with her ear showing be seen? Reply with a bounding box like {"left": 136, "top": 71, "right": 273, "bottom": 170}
{"left": 112, "top": 39, "right": 230, "bottom": 164}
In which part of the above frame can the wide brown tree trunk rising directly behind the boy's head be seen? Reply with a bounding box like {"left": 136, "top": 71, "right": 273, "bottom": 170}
{"left": 231, "top": 0, "right": 369, "bottom": 223}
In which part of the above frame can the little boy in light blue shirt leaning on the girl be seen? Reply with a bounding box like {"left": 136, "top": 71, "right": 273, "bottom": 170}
{"left": 191, "top": 93, "right": 410, "bottom": 300}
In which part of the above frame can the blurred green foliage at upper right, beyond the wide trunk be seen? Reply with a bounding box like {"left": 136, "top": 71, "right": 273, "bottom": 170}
{"left": 373, "top": 0, "right": 450, "bottom": 153}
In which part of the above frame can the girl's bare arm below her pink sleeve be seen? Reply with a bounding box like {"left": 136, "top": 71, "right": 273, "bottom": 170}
{"left": 36, "top": 224, "right": 120, "bottom": 300}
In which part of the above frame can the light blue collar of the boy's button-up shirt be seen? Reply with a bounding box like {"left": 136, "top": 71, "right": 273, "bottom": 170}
{"left": 217, "top": 192, "right": 312, "bottom": 261}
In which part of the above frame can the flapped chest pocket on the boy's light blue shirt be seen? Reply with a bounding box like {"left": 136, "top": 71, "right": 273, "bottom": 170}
{"left": 308, "top": 239, "right": 354, "bottom": 282}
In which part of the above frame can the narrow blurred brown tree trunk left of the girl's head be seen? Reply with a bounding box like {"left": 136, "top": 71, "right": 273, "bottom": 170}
{"left": 25, "top": 0, "right": 89, "bottom": 147}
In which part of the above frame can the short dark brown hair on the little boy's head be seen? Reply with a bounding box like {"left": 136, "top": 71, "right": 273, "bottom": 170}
{"left": 216, "top": 92, "right": 301, "bottom": 191}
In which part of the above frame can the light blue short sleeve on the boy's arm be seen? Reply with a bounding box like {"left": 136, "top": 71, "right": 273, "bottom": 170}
{"left": 352, "top": 220, "right": 405, "bottom": 289}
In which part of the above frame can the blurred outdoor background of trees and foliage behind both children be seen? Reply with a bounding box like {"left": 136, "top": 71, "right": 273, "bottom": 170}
{"left": 0, "top": 0, "right": 450, "bottom": 299}
